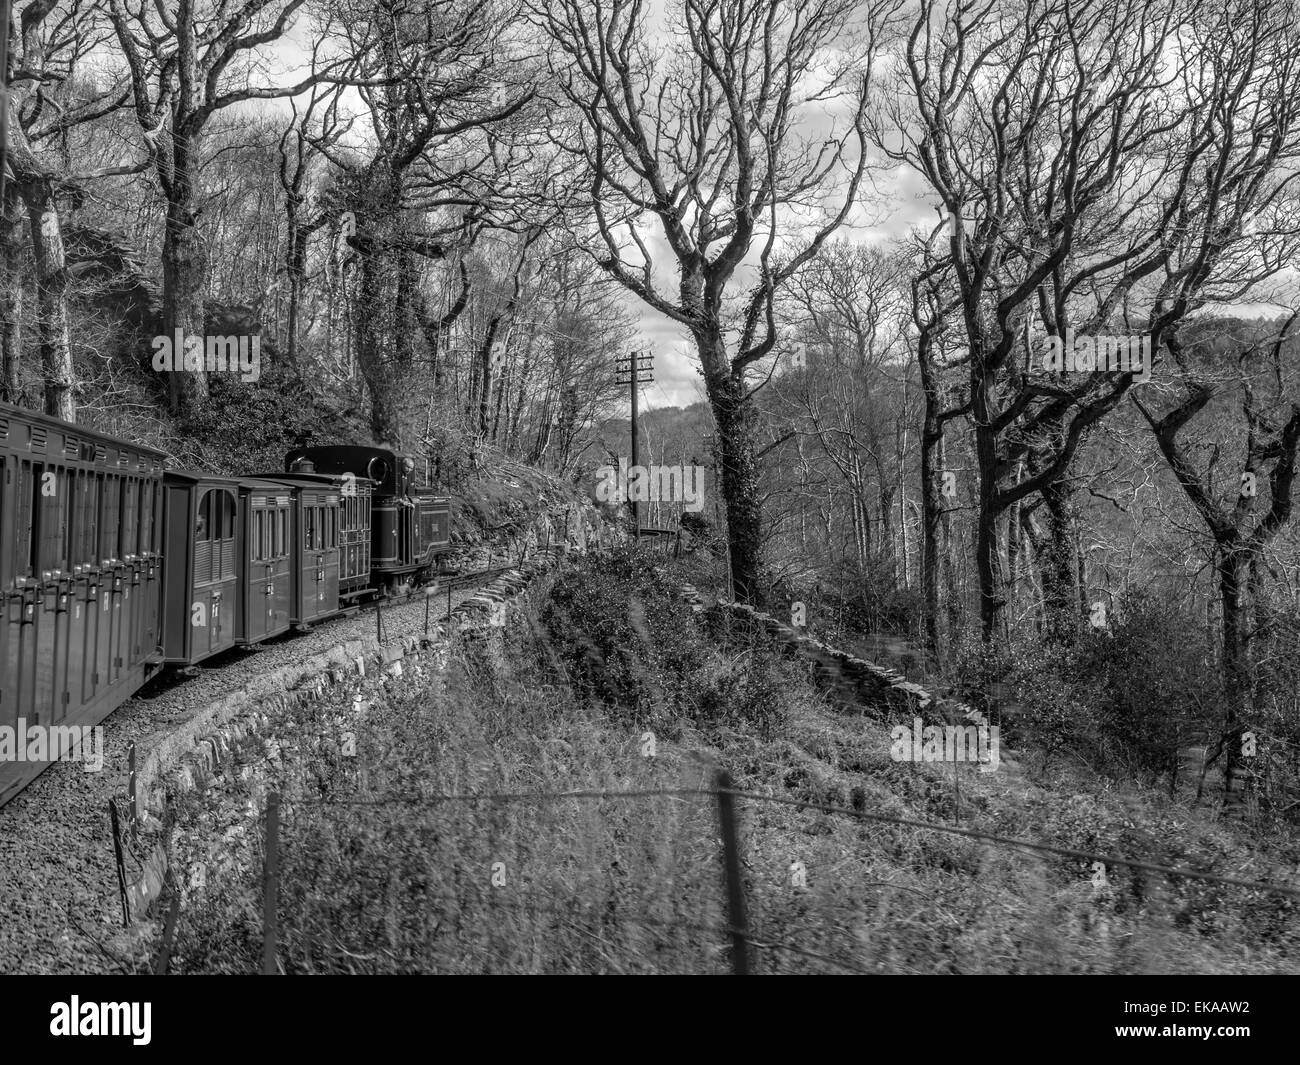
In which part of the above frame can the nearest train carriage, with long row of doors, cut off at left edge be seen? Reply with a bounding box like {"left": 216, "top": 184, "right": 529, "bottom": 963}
{"left": 0, "top": 404, "right": 164, "bottom": 805}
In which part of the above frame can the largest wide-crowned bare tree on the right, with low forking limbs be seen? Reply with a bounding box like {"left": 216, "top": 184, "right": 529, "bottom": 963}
{"left": 879, "top": 0, "right": 1294, "bottom": 638}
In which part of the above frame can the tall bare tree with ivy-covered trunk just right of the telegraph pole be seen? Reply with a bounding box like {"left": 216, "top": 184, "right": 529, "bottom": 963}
{"left": 533, "top": 0, "right": 897, "bottom": 599}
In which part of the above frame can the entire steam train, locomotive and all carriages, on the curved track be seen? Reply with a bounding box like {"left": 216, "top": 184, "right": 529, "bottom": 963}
{"left": 0, "top": 404, "right": 450, "bottom": 806}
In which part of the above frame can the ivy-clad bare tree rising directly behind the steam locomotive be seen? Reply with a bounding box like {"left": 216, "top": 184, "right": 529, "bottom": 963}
{"left": 317, "top": 0, "right": 534, "bottom": 443}
